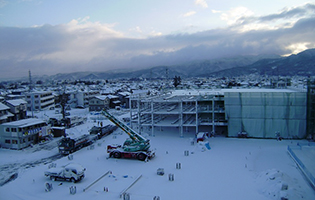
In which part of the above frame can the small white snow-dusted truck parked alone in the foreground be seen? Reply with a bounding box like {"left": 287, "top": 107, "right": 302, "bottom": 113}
{"left": 44, "top": 163, "right": 86, "bottom": 183}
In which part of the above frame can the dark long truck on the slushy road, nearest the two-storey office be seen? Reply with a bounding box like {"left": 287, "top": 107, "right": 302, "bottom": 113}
{"left": 58, "top": 134, "right": 97, "bottom": 155}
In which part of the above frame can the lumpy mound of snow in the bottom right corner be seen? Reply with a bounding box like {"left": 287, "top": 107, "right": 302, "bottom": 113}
{"left": 257, "top": 169, "right": 304, "bottom": 200}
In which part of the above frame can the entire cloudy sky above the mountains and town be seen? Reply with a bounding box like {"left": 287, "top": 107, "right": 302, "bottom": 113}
{"left": 0, "top": 0, "right": 315, "bottom": 80}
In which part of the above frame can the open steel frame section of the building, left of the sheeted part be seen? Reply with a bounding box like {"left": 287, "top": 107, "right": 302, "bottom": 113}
{"left": 130, "top": 92, "right": 227, "bottom": 137}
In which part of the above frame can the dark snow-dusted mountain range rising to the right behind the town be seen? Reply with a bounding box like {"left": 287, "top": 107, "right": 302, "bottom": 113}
{"left": 40, "top": 49, "right": 315, "bottom": 80}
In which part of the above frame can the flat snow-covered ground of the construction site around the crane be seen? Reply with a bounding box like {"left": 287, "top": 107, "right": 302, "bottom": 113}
{"left": 0, "top": 110, "right": 315, "bottom": 200}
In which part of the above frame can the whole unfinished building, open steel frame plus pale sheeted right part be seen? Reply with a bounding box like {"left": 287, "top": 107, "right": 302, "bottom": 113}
{"left": 130, "top": 89, "right": 308, "bottom": 138}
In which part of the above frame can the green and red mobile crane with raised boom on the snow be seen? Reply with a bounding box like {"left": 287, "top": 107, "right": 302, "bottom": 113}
{"left": 101, "top": 109, "right": 155, "bottom": 161}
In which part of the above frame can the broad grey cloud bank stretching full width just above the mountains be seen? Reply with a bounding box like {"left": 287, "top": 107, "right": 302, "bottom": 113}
{"left": 0, "top": 5, "right": 315, "bottom": 78}
